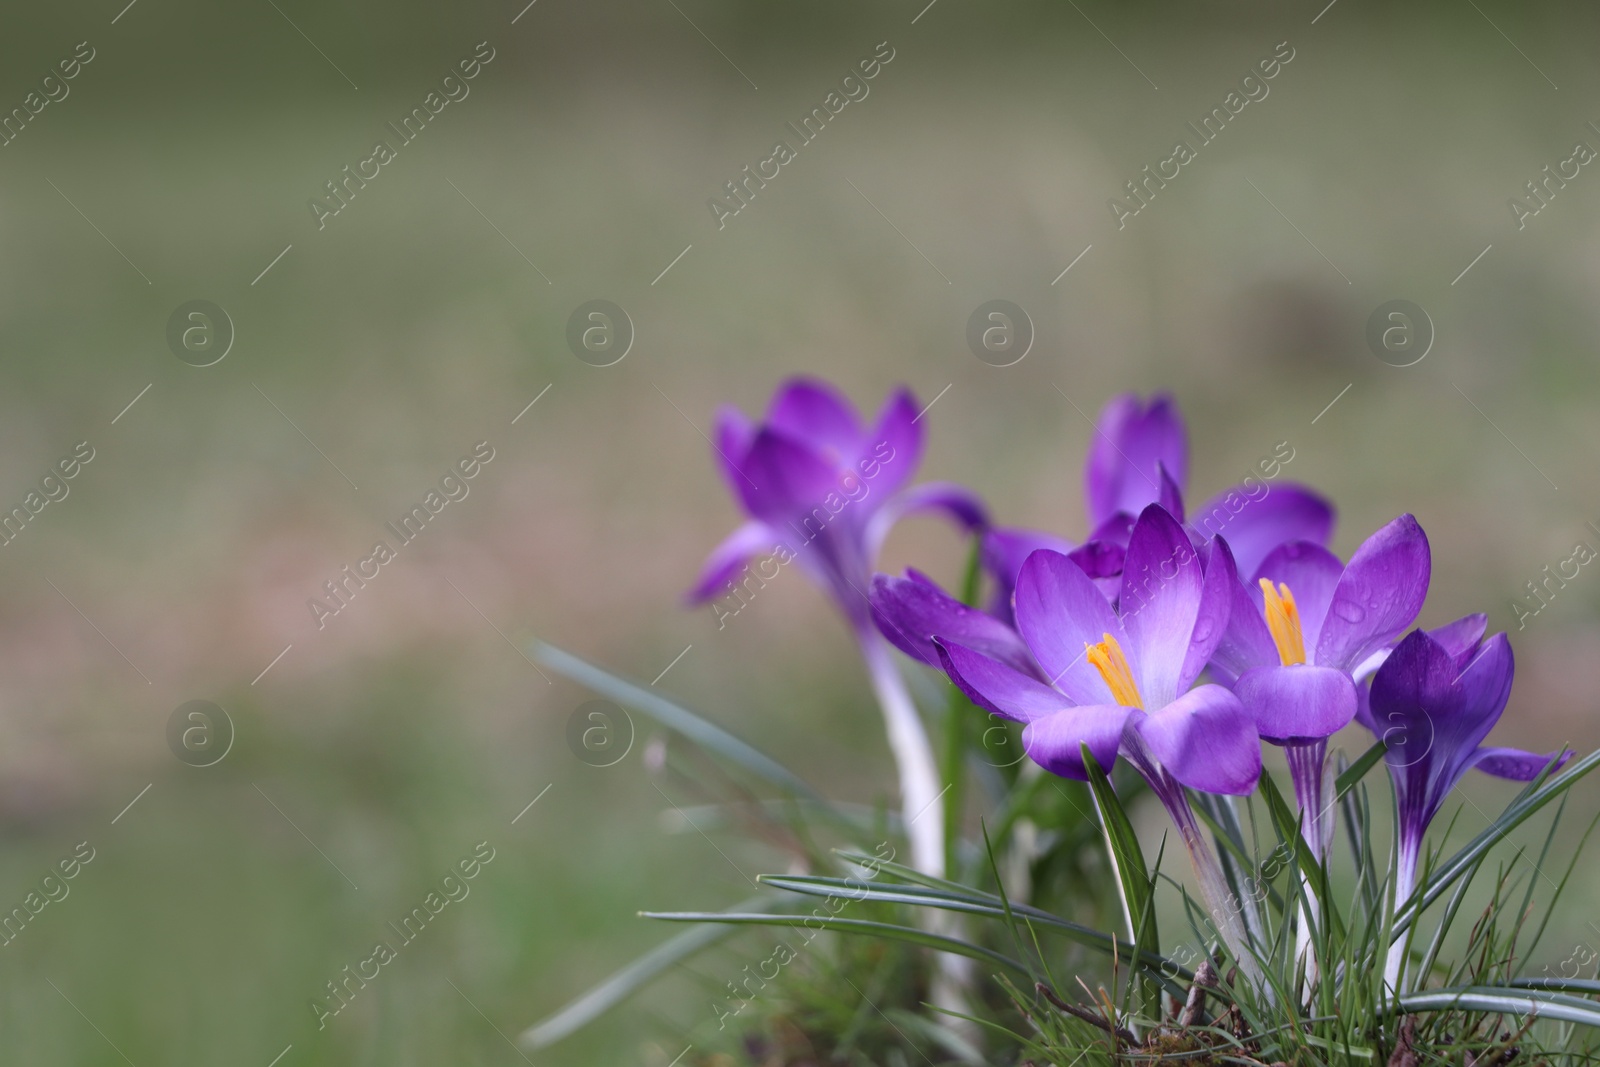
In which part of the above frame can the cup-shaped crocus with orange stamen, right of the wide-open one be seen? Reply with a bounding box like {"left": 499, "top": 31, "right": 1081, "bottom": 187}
{"left": 1211, "top": 515, "right": 1432, "bottom": 859}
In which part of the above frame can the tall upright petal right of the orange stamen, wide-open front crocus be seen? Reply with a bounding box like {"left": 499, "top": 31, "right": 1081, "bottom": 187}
{"left": 1120, "top": 504, "right": 1205, "bottom": 707}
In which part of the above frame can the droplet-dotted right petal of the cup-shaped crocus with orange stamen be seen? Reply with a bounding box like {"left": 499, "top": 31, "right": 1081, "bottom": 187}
{"left": 1314, "top": 515, "right": 1432, "bottom": 670}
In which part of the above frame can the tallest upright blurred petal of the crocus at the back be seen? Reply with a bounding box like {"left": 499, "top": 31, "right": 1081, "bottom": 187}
{"left": 1083, "top": 394, "right": 1189, "bottom": 526}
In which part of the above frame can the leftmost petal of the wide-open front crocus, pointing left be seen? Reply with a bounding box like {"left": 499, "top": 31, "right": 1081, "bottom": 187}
{"left": 869, "top": 574, "right": 1038, "bottom": 675}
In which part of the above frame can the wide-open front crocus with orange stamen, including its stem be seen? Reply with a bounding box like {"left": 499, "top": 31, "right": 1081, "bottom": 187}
{"left": 874, "top": 504, "right": 1261, "bottom": 971}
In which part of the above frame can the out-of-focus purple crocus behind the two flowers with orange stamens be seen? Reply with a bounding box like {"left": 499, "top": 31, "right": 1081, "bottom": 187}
{"left": 984, "top": 394, "right": 1333, "bottom": 617}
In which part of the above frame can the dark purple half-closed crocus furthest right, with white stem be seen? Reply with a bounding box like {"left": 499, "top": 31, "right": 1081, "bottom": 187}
{"left": 1360, "top": 614, "right": 1571, "bottom": 990}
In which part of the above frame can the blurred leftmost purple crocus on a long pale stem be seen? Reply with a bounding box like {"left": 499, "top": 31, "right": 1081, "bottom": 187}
{"left": 690, "top": 379, "right": 986, "bottom": 875}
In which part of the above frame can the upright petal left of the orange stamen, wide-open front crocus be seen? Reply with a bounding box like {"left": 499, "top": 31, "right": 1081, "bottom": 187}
{"left": 1016, "top": 549, "right": 1123, "bottom": 704}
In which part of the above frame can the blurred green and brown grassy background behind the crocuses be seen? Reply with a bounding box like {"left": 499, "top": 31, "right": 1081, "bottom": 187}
{"left": 0, "top": 0, "right": 1600, "bottom": 1067}
